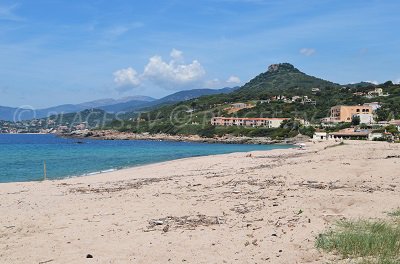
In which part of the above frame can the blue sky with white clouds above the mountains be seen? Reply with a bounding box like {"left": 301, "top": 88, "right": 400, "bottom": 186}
{"left": 0, "top": 0, "right": 400, "bottom": 108}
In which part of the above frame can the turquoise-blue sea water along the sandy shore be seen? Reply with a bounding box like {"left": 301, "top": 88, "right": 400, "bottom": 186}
{"left": 0, "top": 134, "right": 291, "bottom": 182}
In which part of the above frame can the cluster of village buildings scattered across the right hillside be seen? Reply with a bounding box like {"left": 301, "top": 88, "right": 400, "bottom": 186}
{"left": 211, "top": 88, "right": 400, "bottom": 141}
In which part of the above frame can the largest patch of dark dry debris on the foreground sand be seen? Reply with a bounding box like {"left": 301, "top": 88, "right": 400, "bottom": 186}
{"left": 144, "top": 214, "right": 225, "bottom": 232}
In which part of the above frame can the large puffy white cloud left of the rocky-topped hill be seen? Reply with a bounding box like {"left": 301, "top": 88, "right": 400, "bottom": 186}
{"left": 114, "top": 49, "right": 206, "bottom": 91}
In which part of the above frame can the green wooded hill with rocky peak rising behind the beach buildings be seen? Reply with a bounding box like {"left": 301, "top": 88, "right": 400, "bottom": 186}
{"left": 94, "top": 63, "right": 400, "bottom": 138}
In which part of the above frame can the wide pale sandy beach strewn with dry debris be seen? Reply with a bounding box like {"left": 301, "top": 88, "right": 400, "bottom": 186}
{"left": 0, "top": 141, "right": 400, "bottom": 264}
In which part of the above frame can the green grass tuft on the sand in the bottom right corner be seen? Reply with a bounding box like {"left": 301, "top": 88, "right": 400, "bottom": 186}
{"left": 316, "top": 217, "right": 400, "bottom": 264}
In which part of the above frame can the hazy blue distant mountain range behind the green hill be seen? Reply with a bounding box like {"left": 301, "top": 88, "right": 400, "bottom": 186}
{"left": 0, "top": 88, "right": 236, "bottom": 121}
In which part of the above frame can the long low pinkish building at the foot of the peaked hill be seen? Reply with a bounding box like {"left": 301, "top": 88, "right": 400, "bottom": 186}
{"left": 211, "top": 117, "right": 289, "bottom": 128}
